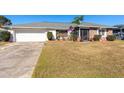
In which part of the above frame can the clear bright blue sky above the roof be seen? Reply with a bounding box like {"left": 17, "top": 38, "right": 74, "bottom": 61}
{"left": 6, "top": 15, "right": 124, "bottom": 26}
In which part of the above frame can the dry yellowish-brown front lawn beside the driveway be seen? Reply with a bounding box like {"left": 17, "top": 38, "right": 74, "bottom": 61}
{"left": 32, "top": 41, "right": 124, "bottom": 78}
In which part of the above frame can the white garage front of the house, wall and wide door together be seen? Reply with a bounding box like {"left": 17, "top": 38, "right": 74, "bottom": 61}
{"left": 10, "top": 28, "right": 56, "bottom": 42}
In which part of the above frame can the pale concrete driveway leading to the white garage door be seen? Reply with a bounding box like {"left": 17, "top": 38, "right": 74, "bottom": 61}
{"left": 0, "top": 43, "right": 43, "bottom": 78}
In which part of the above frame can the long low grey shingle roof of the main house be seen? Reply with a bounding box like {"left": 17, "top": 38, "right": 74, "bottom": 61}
{"left": 5, "top": 22, "right": 113, "bottom": 29}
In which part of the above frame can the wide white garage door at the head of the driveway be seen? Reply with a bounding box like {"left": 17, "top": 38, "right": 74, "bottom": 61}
{"left": 16, "top": 30, "right": 46, "bottom": 42}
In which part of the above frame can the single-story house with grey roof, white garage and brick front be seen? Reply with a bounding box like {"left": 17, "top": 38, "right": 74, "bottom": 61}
{"left": 4, "top": 22, "right": 115, "bottom": 42}
